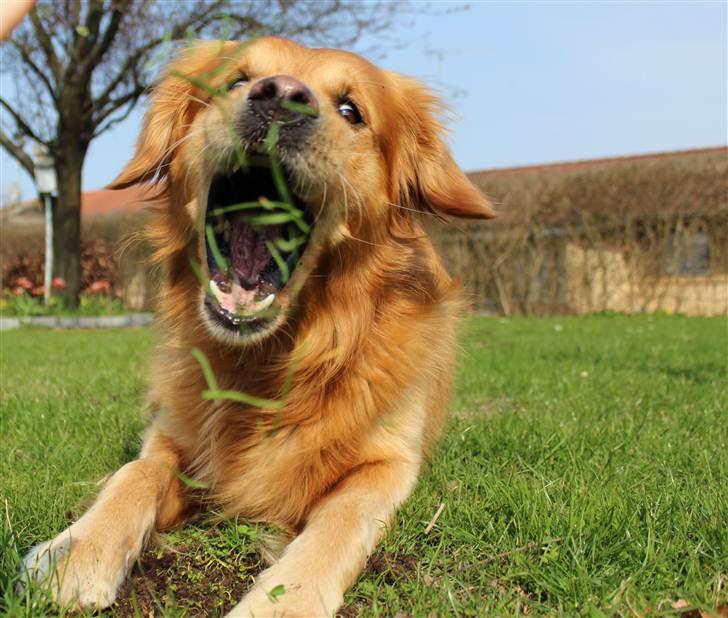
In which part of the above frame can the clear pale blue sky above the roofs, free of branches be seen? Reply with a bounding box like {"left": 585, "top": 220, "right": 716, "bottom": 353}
{"left": 0, "top": 0, "right": 728, "bottom": 197}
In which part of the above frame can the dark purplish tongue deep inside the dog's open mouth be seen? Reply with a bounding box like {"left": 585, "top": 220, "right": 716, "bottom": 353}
{"left": 230, "top": 218, "right": 283, "bottom": 286}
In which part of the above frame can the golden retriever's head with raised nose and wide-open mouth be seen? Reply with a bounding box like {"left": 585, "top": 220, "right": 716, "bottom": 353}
{"left": 112, "top": 38, "right": 493, "bottom": 343}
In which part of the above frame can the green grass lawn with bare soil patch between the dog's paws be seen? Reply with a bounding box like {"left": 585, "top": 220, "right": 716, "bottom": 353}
{"left": 0, "top": 315, "right": 728, "bottom": 616}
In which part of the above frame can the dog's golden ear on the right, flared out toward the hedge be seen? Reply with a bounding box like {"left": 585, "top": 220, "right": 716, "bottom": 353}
{"left": 391, "top": 74, "right": 495, "bottom": 219}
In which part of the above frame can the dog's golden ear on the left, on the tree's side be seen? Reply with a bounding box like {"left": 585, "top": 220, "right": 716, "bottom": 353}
{"left": 108, "top": 41, "right": 236, "bottom": 189}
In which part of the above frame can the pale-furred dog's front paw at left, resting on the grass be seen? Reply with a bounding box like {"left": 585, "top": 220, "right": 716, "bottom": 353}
{"left": 19, "top": 527, "right": 127, "bottom": 609}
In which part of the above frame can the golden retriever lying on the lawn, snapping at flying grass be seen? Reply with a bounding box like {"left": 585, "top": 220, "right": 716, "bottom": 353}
{"left": 19, "top": 38, "right": 493, "bottom": 616}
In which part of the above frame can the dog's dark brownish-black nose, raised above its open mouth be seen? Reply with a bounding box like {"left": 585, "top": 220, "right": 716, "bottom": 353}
{"left": 248, "top": 75, "right": 319, "bottom": 121}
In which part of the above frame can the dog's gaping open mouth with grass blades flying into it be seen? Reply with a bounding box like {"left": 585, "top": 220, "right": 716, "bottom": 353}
{"left": 205, "top": 157, "right": 313, "bottom": 332}
